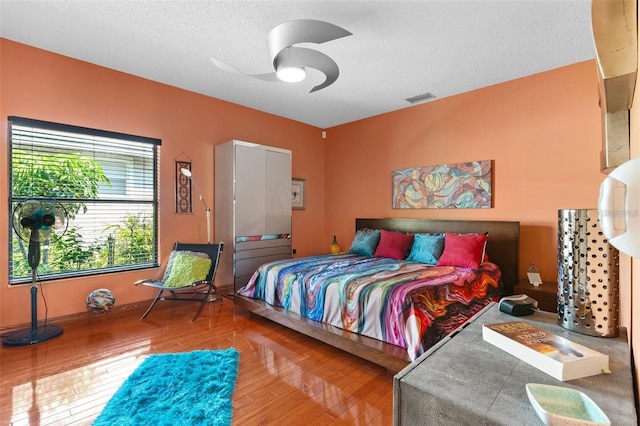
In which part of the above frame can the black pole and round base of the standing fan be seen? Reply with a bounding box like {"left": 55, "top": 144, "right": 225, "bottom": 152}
{"left": 2, "top": 230, "right": 62, "bottom": 346}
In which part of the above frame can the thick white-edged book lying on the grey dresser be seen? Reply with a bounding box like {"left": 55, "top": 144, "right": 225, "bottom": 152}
{"left": 482, "top": 321, "right": 609, "bottom": 381}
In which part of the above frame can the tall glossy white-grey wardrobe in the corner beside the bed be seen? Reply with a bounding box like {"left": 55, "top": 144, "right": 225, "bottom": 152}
{"left": 214, "top": 140, "right": 291, "bottom": 293}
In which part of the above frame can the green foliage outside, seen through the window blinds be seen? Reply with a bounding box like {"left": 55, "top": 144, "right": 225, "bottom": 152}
{"left": 12, "top": 150, "right": 155, "bottom": 278}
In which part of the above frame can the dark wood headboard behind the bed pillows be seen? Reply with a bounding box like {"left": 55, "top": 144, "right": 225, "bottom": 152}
{"left": 356, "top": 218, "right": 520, "bottom": 294}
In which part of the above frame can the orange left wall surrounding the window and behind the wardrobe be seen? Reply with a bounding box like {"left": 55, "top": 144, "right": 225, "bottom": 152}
{"left": 0, "top": 39, "right": 326, "bottom": 329}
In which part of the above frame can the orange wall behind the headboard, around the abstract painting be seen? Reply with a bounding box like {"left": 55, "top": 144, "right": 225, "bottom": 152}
{"left": 325, "top": 61, "right": 616, "bottom": 308}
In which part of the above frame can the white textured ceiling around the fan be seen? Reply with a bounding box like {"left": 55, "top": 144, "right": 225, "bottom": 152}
{"left": 0, "top": 0, "right": 595, "bottom": 128}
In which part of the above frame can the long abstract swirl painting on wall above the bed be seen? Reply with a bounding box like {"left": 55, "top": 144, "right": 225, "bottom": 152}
{"left": 392, "top": 160, "right": 493, "bottom": 209}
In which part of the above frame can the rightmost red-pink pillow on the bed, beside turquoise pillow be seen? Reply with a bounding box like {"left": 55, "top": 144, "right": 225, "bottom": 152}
{"left": 437, "top": 232, "right": 488, "bottom": 269}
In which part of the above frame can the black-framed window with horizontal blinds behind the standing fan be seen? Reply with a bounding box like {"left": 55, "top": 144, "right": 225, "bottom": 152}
{"left": 9, "top": 117, "right": 161, "bottom": 284}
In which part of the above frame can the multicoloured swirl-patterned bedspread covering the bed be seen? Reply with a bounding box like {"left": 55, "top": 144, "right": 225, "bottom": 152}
{"left": 238, "top": 254, "right": 501, "bottom": 360}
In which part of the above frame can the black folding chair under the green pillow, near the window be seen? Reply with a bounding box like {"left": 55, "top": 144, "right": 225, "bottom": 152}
{"left": 134, "top": 242, "right": 224, "bottom": 321}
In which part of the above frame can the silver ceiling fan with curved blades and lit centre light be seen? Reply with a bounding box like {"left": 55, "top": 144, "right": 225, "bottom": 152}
{"left": 211, "top": 19, "right": 352, "bottom": 93}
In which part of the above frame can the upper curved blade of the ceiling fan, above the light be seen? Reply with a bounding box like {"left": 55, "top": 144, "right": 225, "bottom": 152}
{"left": 267, "top": 19, "right": 352, "bottom": 59}
